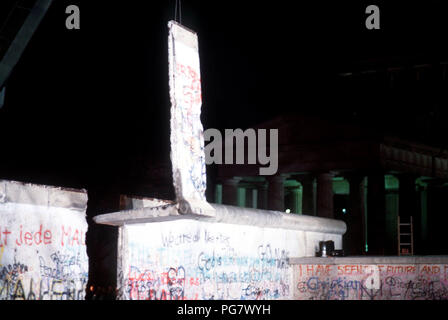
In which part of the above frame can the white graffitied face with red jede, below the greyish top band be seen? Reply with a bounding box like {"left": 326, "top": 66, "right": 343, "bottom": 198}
{"left": 0, "top": 208, "right": 88, "bottom": 300}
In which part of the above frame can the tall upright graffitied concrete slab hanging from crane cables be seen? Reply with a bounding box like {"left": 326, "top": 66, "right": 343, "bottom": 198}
{"left": 168, "top": 21, "right": 207, "bottom": 205}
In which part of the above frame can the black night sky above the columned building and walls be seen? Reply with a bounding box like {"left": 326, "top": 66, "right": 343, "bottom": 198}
{"left": 0, "top": 0, "right": 448, "bottom": 191}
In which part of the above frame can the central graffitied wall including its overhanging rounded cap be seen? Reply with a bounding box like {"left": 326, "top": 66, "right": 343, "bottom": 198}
{"left": 94, "top": 202, "right": 346, "bottom": 300}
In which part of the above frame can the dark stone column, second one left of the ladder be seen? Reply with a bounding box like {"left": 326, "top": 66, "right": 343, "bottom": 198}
{"left": 343, "top": 174, "right": 365, "bottom": 255}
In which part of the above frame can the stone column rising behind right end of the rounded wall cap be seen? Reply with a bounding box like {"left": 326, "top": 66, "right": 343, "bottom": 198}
{"left": 316, "top": 173, "right": 334, "bottom": 219}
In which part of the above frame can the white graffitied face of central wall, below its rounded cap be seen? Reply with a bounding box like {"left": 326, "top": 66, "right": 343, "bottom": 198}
{"left": 118, "top": 221, "right": 297, "bottom": 300}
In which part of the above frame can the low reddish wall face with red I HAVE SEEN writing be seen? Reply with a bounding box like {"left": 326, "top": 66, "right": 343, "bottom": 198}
{"left": 294, "top": 264, "right": 448, "bottom": 300}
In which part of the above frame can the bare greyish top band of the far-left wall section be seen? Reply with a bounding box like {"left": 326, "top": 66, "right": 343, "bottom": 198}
{"left": 0, "top": 180, "right": 87, "bottom": 211}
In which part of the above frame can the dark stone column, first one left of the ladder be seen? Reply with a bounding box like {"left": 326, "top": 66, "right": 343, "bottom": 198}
{"left": 367, "top": 173, "right": 386, "bottom": 255}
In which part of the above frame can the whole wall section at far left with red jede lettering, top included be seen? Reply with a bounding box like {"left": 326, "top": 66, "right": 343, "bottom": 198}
{"left": 0, "top": 180, "right": 89, "bottom": 300}
